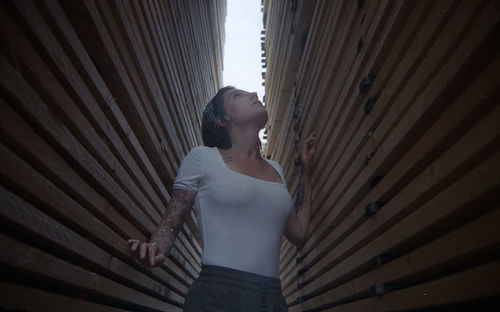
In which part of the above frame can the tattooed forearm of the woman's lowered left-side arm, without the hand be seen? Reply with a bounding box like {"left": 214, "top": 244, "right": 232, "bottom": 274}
{"left": 150, "top": 189, "right": 195, "bottom": 255}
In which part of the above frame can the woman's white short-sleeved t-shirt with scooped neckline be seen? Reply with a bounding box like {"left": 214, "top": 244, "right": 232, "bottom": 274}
{"left": 172, "top": 146, "right": 294, "bottom": 277}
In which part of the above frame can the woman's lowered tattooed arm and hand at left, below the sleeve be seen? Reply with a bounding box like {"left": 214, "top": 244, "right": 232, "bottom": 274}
{"left": 129, "top": 189, "right": 196, "bottom": 266}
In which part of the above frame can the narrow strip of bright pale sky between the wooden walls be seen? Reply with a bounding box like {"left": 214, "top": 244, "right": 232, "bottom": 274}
{"left": 222, "top": 0, "right": 266, "bottom": 143}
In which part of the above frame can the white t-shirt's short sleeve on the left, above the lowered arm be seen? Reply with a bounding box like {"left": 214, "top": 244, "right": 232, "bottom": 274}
{"left": 172, "top": 146, "right": 203, "bottom": 193}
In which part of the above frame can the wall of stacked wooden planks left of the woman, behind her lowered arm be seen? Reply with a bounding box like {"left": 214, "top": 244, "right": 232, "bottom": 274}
{"left": 0, "top": 0, "right": 226, "bottom": 311}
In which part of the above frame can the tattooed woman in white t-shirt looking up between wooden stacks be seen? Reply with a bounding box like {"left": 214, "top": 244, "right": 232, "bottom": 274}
{"left": 129, "top": 86, "right": 315, "bottom": 312}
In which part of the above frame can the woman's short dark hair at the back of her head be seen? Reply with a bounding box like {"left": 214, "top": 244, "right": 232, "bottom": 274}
{"left": 201, "top": 86, "right": 236, "bottom": 148}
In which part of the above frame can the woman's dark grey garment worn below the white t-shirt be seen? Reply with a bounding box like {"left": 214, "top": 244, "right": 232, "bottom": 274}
{"left": 183, "top": 264, "right": 288, "bottom": 312}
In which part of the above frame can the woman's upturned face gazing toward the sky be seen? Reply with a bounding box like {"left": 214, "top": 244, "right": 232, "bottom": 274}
{"left": 224, "top": 89, "right": 268, "bottom": 129}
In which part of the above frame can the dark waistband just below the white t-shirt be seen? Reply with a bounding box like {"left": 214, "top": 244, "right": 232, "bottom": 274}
{"left": 197, "top": 264, "right": 282, "bottom": 295}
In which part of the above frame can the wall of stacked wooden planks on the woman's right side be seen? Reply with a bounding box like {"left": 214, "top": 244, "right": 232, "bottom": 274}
{"left": 263, "top": 0, "right": 500, "bottom": 311}
